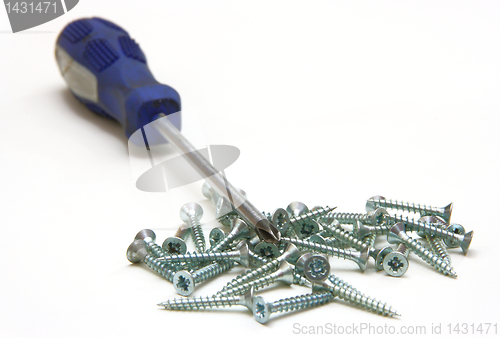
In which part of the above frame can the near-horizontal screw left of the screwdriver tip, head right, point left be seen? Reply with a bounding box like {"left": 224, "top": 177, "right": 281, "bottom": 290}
{"left": 158, "top": 241, "right": 250, "bottom": 267}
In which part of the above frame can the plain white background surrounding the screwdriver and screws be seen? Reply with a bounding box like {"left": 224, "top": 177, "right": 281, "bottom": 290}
{"left": 0, "top": 0, "right": 500, "bottom": 337}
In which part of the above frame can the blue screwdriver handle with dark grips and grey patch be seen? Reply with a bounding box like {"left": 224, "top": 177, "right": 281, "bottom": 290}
{"left": 56, "top": 18, "right": 181, "bottom": 143}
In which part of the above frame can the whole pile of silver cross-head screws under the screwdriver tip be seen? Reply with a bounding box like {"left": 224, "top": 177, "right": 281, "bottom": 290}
{"left": 127, "top": 184, "right": 473, "bottom": 323}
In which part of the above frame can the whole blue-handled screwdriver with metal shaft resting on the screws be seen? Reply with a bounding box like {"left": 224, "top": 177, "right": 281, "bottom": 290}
{"left": 56, "top": 17, "right": 280, "bottom": 242}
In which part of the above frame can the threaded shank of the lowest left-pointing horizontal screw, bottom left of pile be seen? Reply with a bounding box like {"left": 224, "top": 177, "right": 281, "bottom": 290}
{"left": 158, "top": 296, "right": 241, "bottom": 311}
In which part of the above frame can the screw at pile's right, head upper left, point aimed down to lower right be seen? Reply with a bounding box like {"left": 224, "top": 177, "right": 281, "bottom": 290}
{"left": 387, "top": 222, "right": 457, "bottom": 278}
